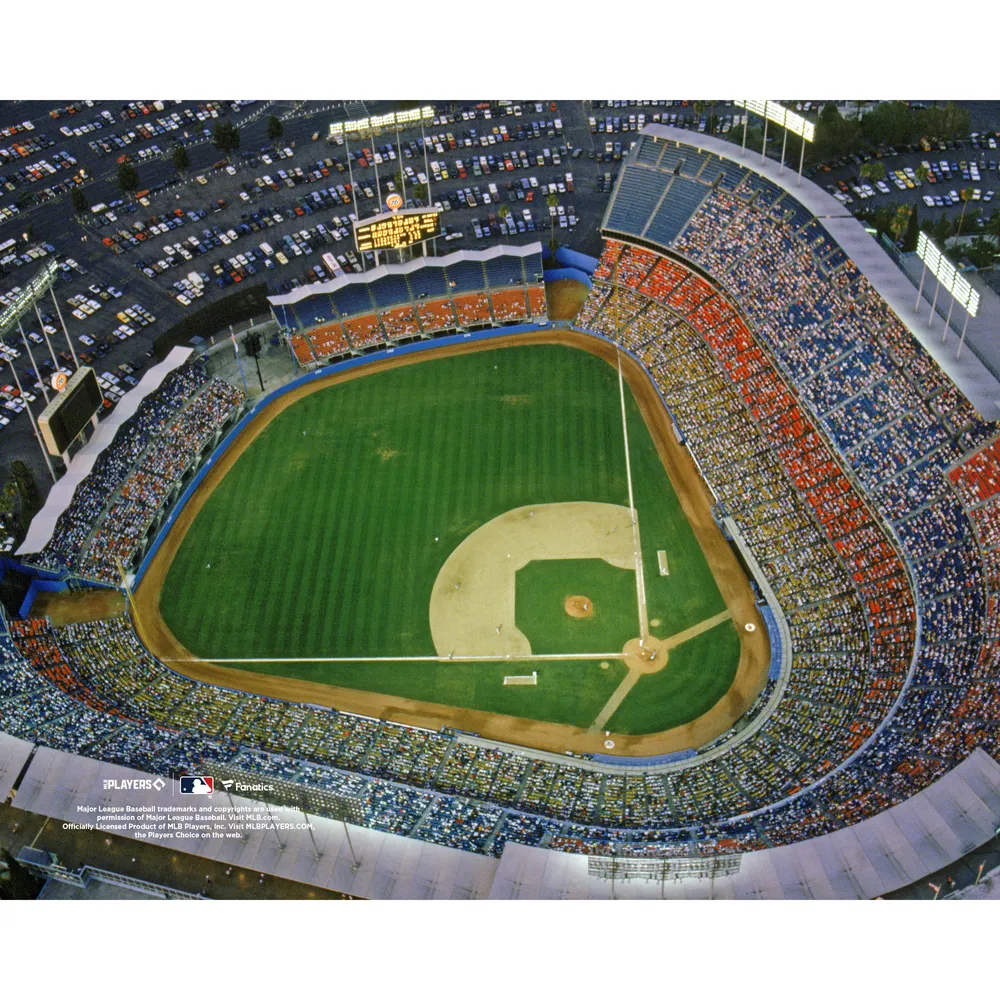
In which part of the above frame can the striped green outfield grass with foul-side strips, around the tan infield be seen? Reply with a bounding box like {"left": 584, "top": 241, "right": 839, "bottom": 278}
{"left": 160, "top": 345, "right": 736, "bottom": 724}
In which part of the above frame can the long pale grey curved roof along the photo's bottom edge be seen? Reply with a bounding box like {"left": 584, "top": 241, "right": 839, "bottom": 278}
{"left": 7, "top": 738, "right": 1000, "bottom": 899}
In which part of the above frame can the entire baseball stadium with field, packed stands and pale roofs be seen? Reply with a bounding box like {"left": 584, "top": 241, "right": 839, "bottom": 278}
{"left": 0, "top": 124, "right": 1000, "bottom": 898}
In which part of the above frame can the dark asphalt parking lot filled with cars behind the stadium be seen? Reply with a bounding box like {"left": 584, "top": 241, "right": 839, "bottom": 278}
{"left": 0, "top": 100, "right": 1000, "bottom": 528}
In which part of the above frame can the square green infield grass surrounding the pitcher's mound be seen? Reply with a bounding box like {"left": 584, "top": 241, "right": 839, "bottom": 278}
{"left": 514, "top": 559, "right": 639, "bottom": 653}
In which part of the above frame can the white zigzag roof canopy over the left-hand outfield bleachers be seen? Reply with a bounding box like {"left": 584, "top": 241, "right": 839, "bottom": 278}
{"left": 16, "top": 347, "right": 191, "bottom": 556}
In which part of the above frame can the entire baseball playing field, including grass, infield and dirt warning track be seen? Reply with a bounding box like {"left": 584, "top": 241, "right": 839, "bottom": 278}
{"left": 137, "top": 335, "right": 767, "bottom": 749}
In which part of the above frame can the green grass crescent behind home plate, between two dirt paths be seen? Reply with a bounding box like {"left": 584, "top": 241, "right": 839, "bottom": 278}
{"left": 608, "top": 621, "right": 740, "bottom": 736}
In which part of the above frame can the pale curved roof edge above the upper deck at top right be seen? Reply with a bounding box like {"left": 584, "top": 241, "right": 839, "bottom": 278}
{"left": 632, "top": 124, "right": 1000, "bottom": 420}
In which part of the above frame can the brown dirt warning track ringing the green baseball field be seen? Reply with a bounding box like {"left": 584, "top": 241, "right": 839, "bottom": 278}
{"left": 132, "top": 330, "right": 770, "bottom": 756}
